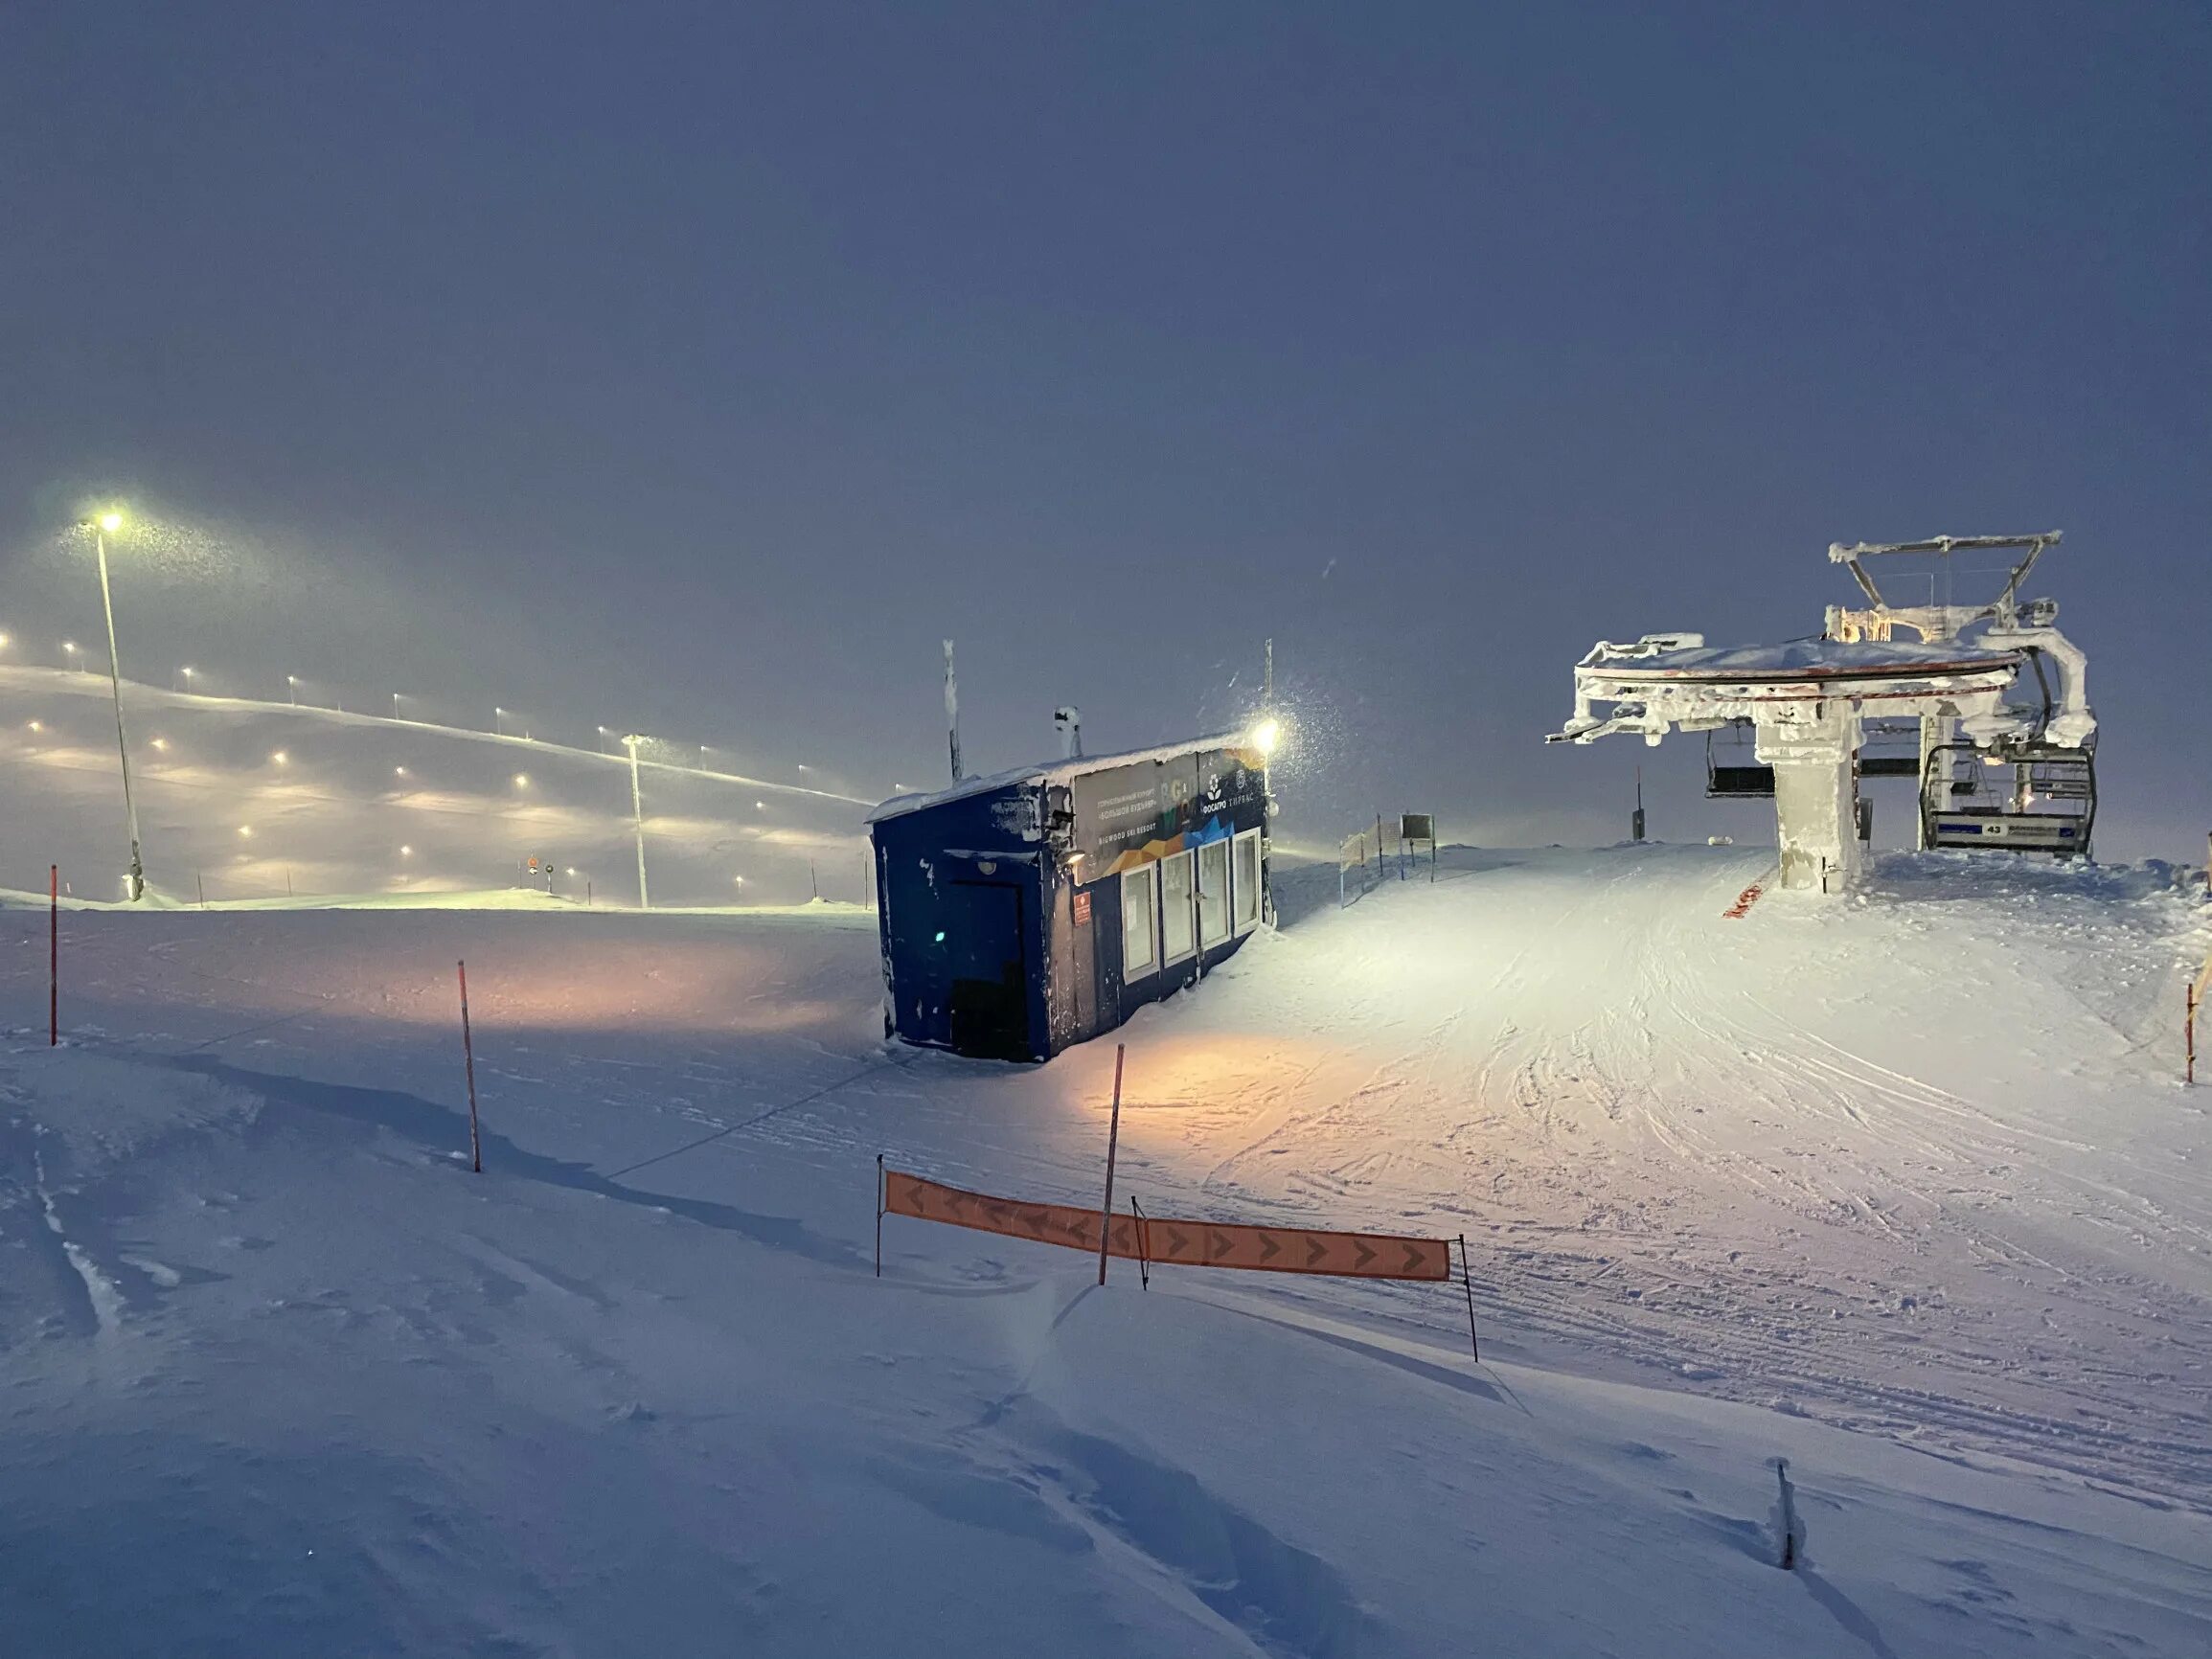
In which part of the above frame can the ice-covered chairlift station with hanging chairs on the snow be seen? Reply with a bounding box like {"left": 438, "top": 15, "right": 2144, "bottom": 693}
{"left": 1546, "top": 531, "right": 2097, "bottom": 894}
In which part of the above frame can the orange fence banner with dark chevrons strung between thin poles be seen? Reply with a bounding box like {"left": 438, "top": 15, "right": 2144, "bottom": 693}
{"left": 882, "top": 1170, "right": 1451, "bottom": 1281}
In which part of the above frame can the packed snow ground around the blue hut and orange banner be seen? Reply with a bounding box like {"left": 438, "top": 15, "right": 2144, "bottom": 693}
{"left": 0, "top": 847, "right": 2212, "bottom": 1659}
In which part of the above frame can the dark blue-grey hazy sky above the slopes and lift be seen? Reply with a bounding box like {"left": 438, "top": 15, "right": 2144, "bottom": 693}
{"left": 0, "top": 5, "right": 2212, "bottom": 856}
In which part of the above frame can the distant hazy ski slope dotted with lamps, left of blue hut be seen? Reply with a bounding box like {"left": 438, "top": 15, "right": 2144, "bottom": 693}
{"left": 0, "top": 664, "right": 880, "bottom": 907}
